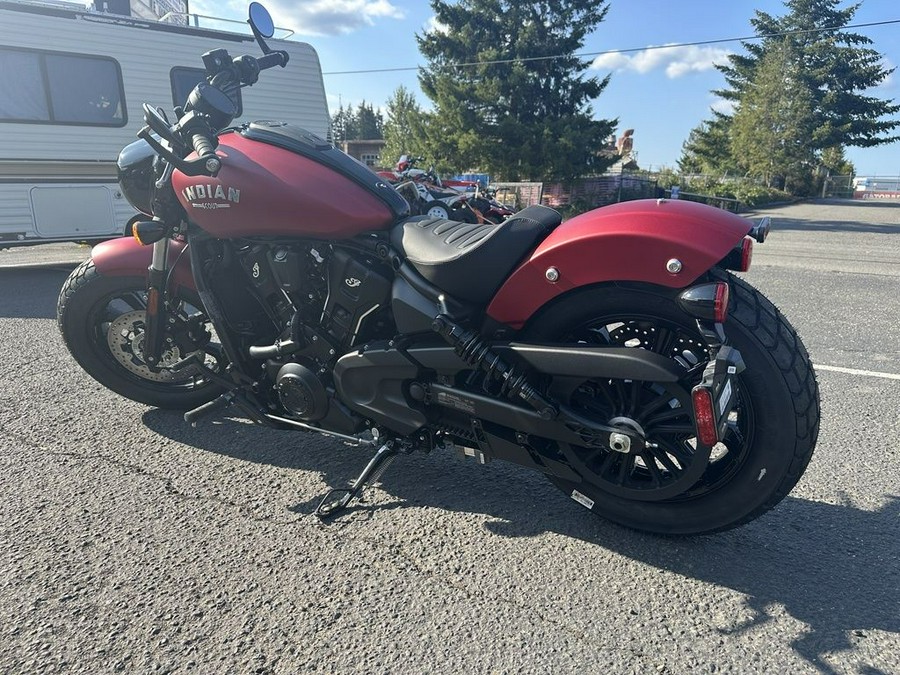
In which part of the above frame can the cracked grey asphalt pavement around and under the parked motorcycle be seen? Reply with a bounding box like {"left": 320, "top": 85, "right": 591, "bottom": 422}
{"left": 0, "top": 202, "right": 900, "bottom": 675}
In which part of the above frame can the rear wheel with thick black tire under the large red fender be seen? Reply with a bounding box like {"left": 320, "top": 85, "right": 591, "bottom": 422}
{"left": 527, "top": 273, "right": 819, "bottom": 534}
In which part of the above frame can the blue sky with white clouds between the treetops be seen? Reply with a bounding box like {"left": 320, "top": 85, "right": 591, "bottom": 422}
{"left": 190, "top": 0, "right": 900, "bottom": 176}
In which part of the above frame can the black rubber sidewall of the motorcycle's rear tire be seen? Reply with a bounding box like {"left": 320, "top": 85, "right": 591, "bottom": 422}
{"left": 526, "top": 286, "right": 798, "bottom": 534}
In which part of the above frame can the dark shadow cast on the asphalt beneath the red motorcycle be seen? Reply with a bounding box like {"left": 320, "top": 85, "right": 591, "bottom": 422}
{"left": 143, "top": 410, "right": 900, "bottom": 675}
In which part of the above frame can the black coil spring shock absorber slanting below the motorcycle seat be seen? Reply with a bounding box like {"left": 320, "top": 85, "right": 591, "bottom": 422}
{"left": 431, "top": 314, "right": 559, "bottom": 420}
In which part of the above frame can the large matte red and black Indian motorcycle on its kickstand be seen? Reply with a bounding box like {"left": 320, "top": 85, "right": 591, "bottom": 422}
{"left": 52, "top": 3, "right": 819, "bottom": 534}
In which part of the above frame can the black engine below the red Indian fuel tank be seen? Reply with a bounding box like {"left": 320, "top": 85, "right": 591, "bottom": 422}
{"left": 230, "top": 243, "right": 393, "bottom": 433}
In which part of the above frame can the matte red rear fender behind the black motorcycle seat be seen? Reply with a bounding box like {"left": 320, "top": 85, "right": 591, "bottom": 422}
{"left": 487, "top": 199, "right": 752, "bottom": 329}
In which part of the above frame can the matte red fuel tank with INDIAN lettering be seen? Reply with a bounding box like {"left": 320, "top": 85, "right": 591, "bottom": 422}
{"left": 172, "top": 122, "right": 409, "bottom": 239}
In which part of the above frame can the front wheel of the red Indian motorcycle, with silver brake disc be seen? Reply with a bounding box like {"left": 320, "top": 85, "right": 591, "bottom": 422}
{"left": 57, "top": 260, "right": 222, "bottom": 410}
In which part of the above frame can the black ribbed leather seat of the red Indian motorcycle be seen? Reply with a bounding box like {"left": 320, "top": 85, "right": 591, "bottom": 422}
{"left": 391, "top": 206, "right": 562, "bottom": 304}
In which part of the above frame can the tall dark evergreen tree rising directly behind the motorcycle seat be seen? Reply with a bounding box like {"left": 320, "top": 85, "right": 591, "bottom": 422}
{"left": 417, "top": 0, "right": 615, "bottom": 180}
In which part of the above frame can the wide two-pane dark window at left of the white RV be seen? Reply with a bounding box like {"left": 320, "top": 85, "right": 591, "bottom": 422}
{"left": 0, "top": 49, "right": 127, "bottom": 127}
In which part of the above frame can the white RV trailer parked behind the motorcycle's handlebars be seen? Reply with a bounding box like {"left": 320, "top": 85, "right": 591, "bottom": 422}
{"left": 0, "top": 0, "right": 330, "bottom": 248}
